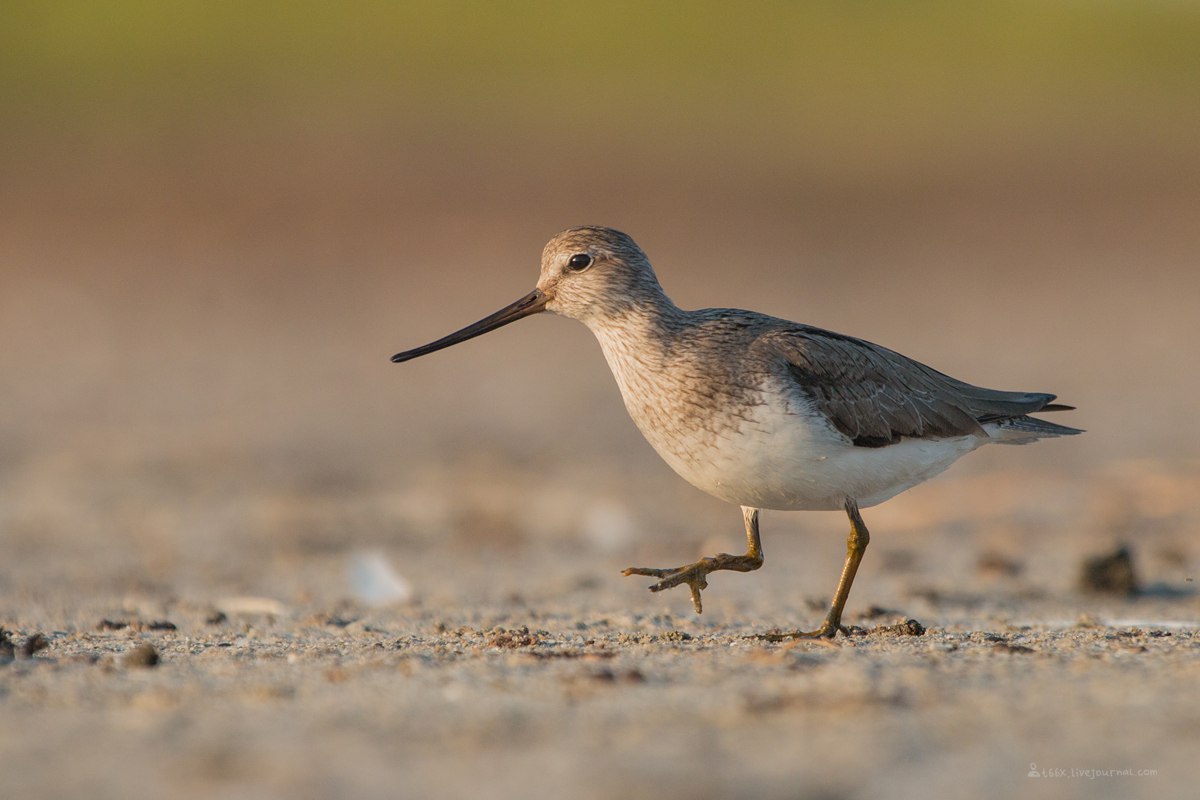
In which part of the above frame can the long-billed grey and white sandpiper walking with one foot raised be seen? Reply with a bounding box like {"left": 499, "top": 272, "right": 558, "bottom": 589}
{"left": 391, "top": 225, "right": 1081, "bottom": 638}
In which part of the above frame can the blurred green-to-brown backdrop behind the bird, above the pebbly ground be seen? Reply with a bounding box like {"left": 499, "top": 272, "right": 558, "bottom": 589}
{"left": 0, "top": 1, "right": 1200, "bottom": 613}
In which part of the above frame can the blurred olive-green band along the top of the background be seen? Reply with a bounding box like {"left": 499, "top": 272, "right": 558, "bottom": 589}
{"left": 7, "top": 1, "right": 1200, "bottom": 179}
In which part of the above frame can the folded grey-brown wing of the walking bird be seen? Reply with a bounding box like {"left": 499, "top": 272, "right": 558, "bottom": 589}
{"left": 758, "top": 325, "right": 1069, "bottom": 447}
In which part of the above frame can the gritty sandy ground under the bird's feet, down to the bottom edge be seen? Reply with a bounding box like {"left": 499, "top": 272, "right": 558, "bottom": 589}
{"left": 2, "top": 603, "right": 1200, "bottom": 798}
